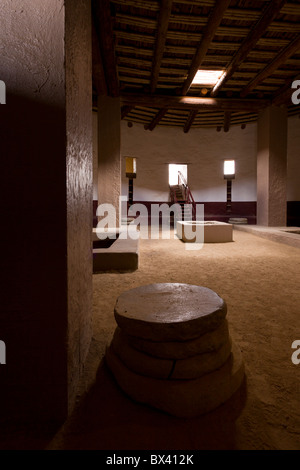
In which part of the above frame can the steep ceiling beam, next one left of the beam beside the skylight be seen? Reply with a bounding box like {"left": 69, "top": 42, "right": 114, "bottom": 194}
{"left": 150, "top": 0, "right": 173, "bottom": 93}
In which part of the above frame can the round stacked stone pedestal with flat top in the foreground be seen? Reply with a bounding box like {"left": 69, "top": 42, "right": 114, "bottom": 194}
{"left": 106, "top": 284, "right": 244, "bottom": 418}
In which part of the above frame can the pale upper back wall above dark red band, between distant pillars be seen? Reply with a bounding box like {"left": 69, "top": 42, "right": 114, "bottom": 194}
{"left": 121, "top": 122, "right": 256, "bottom": 202}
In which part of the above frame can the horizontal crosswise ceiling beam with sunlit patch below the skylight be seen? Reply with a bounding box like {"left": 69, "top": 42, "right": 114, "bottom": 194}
{"left": 121, "top": 93, "right": 270, "bottom": 111}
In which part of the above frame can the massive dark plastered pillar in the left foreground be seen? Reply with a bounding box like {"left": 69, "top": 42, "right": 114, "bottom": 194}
{"left": 0, "top": 0, "right": 92, "bottom": 427}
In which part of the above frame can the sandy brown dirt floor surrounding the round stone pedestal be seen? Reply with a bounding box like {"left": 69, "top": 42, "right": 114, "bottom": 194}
{"left": 42, "top": 231, "right": 300, "bottom": 450}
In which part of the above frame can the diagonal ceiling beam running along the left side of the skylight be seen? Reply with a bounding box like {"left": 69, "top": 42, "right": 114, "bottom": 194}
{"left": 181, "top": 0, "right": 230, "bottom": 95}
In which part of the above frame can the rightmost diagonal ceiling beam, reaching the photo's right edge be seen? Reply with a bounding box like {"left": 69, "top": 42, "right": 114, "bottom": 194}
{"left": 240, "top": 34, "right": 300, "bottom": 97}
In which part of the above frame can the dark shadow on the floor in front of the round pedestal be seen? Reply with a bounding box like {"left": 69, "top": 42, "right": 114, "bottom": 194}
{"left": 55, "top": 360, "right": 247, "bottom": 450}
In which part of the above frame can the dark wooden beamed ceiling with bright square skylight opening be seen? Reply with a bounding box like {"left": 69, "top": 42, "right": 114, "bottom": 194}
{"left": 91, "top": 0, "right": 300, "bottom": 132}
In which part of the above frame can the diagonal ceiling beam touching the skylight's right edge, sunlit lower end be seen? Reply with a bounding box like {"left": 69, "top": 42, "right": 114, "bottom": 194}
{"left": 210, "top": 0, "right": 287, "bottom": 97}
